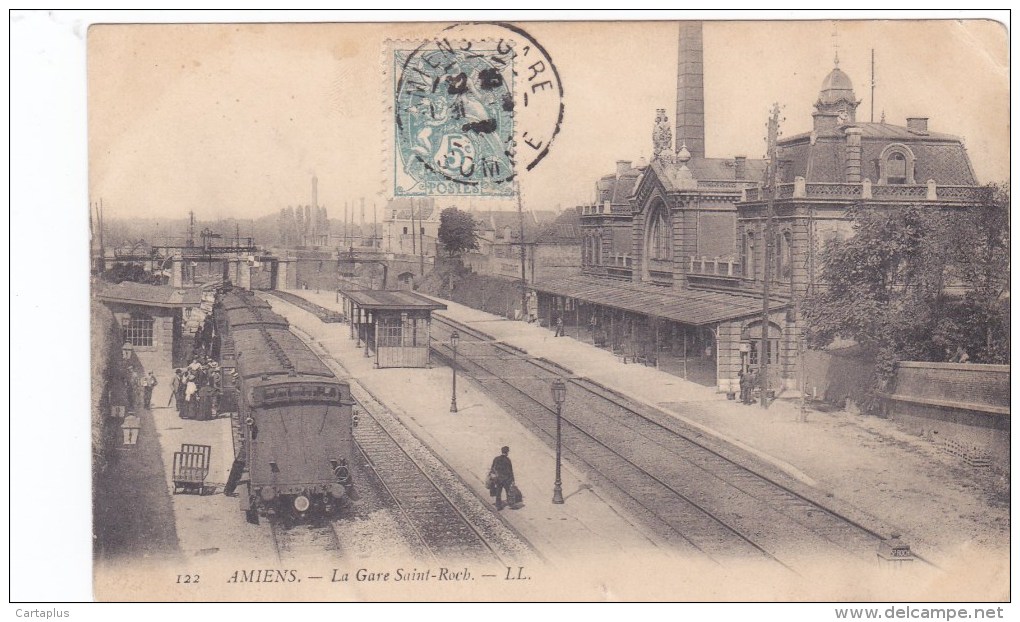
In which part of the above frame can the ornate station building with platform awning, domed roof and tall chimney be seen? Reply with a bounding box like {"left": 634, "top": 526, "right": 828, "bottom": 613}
{"left": 532, "top": 22, "right": 986, "bottom": 392}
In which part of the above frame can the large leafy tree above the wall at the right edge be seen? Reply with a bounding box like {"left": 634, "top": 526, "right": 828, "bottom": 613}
{"left": 804, "top": 185, "right": 1010, "bottom": 407}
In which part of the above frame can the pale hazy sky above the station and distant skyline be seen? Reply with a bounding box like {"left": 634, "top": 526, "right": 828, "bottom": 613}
{"left": 87, "top": 20, "right": 1009, "bottom": 219}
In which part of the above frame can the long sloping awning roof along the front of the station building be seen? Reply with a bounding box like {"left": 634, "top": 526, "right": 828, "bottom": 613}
{"left": 532, "top": 276, "right": 788, "bottom": 326}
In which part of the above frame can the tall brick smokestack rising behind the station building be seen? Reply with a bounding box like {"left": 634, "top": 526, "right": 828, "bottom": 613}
{"left": 673, "top": 21, "right": 705, "bottom": 158}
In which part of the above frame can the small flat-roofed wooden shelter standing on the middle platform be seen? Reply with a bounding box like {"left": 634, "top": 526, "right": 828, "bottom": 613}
{"left": 340, "top": 289, "right": 447, "bottom": 367}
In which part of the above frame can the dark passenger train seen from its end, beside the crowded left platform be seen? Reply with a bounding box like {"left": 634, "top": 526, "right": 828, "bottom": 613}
{"left": 213, "top": 289, "right": 357, "bottom": 523}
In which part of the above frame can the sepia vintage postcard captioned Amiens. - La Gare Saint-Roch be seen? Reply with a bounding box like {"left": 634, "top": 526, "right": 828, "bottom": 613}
{"left": 83, "top": 19, "right": 1011, "bottom": 603}
